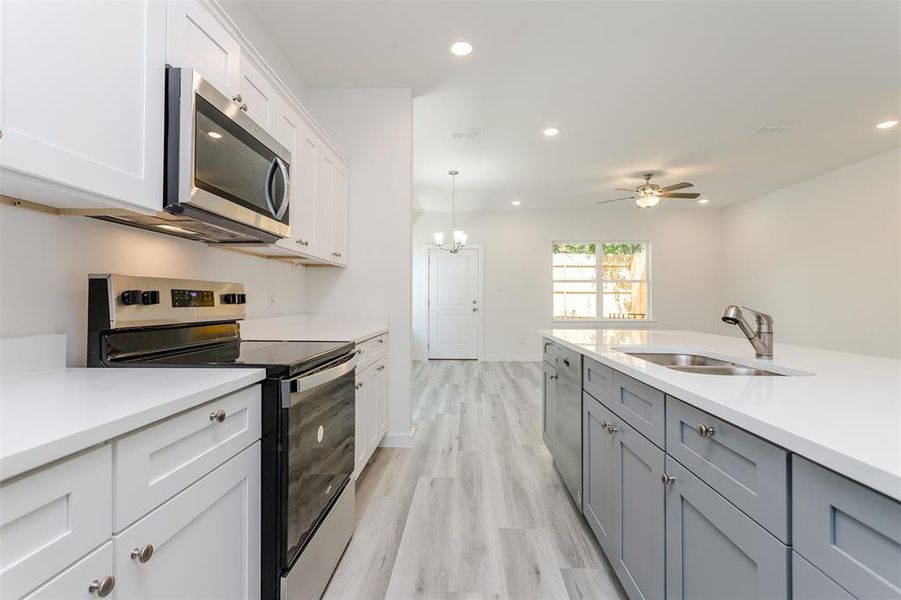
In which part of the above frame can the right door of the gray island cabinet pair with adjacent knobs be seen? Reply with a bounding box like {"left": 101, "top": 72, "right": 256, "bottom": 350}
{"left": 608, "top": 413, "right": 665, "bottom": 600}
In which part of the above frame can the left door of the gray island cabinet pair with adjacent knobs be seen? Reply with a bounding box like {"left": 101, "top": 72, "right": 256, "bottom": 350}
{"left": 582, "top": 393, "right": 616, "bottom": 556}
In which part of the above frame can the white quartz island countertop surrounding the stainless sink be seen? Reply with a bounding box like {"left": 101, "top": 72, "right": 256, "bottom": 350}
{"left": 539, "top": 329, "right": 901, "bottom": 500}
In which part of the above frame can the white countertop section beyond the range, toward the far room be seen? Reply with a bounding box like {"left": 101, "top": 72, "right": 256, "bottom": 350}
{"left": 241, "top": 313, "right": 388, "bottom": 343}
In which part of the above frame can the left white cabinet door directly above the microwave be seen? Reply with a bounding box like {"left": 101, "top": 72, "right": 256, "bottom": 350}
{"left": 166, "top": 0, "right": 241, "bottom": 98}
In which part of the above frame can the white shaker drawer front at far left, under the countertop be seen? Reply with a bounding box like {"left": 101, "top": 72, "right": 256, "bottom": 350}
{"left": 0, "top": 446, "right": 112, "bottom": 598}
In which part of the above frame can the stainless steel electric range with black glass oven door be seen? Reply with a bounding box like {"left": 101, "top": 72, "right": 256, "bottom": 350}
{"left": 88, "top": 274, "right": 358, "bottom": 600}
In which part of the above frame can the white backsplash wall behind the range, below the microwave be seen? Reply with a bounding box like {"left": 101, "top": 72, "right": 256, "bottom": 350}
{"left": 0, "top": 206, "right": 306, "bottom": 366}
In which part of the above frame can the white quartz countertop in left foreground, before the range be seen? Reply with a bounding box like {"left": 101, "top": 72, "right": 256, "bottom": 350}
{"left": 0, "top": 368, "right": 266, "bottom": 481}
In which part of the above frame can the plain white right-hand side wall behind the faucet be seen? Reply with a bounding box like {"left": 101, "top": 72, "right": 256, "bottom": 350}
{"left": 723, "top": 150, "right": 901, "bottom": 357}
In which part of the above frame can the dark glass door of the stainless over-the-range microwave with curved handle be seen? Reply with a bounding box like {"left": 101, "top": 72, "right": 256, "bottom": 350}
{"left": 194, "top": 94, "right": 289, "bottom": 224}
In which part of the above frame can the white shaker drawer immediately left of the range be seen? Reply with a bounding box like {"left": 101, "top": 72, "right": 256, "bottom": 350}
{"left": 113, "top": 385, "right": 261, "bottom": 531}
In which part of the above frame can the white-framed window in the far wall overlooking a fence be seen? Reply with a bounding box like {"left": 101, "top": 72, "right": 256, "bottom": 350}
{"left": 551, "top": 241, "right": 650, "bottom": 321}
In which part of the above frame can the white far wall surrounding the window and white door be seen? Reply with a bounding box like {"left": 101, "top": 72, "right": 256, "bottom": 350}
{"left": 413, "top": 206, "right": 722, "bottom": 360}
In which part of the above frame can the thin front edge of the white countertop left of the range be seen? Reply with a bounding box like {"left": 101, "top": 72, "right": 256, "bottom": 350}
{"left": 0, "top": 369, "right": 266, "bottom": 483}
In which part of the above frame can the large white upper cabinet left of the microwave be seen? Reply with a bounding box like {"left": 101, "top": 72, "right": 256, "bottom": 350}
{"left": 0, "top": 0, "right": 166, "bottom": 211}
